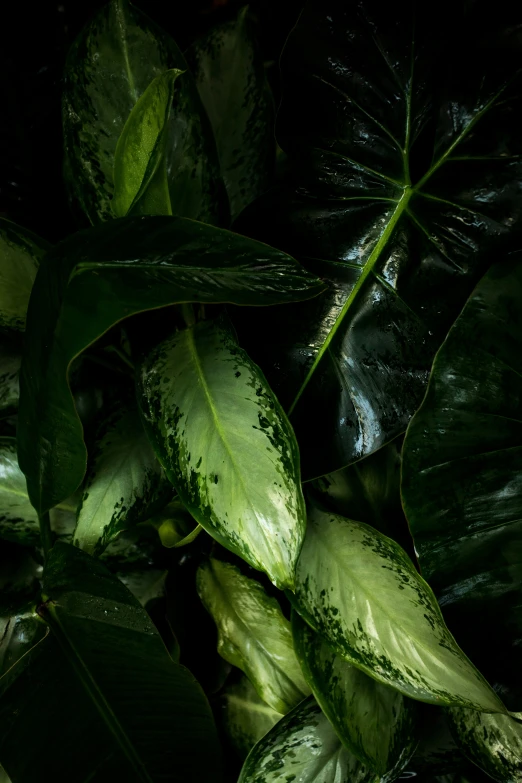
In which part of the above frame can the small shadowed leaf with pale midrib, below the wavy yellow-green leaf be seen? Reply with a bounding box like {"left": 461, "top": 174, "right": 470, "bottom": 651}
{"left": 220, "top": 675, "right": 283, "bottom": 761}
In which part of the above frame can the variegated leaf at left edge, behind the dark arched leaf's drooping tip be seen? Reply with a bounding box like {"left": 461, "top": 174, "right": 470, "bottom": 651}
{"left": 0, "top": 436, "right": 76, "bottom": 546}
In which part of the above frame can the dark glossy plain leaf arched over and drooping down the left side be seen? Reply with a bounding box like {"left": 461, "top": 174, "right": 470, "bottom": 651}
{"left": 18, "top": 216, "right": 323, "bottom": 513}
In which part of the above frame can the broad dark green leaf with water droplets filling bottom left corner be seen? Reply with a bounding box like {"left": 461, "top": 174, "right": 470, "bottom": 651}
{"left": 0, "top": 543, "right": 220, "bottom": 783}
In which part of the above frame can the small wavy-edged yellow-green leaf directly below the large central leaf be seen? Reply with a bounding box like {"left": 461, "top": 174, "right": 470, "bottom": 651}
{"left": 197, "top": 558, "right": 310, "bottom": 715}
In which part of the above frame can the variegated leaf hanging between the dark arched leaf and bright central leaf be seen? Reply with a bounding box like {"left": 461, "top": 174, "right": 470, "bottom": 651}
{"left": 74, "top": 404, "right": 172, "bottom": 555}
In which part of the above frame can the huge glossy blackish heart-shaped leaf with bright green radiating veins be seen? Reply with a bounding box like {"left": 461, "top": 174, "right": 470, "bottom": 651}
{"left": 233, "top": 0, "right": 522, "bottom": 478}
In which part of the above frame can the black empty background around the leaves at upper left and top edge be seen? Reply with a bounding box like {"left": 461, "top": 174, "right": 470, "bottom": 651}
{"left": 0, "top": 0, "right": 303, "bottom": 242}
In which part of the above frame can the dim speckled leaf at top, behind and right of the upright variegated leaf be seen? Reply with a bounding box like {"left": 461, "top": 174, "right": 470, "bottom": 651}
{"left": 186, "top": 6, "right": 275, "bottom": 218}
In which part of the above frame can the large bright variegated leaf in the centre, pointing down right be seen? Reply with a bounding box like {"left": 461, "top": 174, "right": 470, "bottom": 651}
{"left": 138, "top": 319, "right": 306, "bottom": 588}
